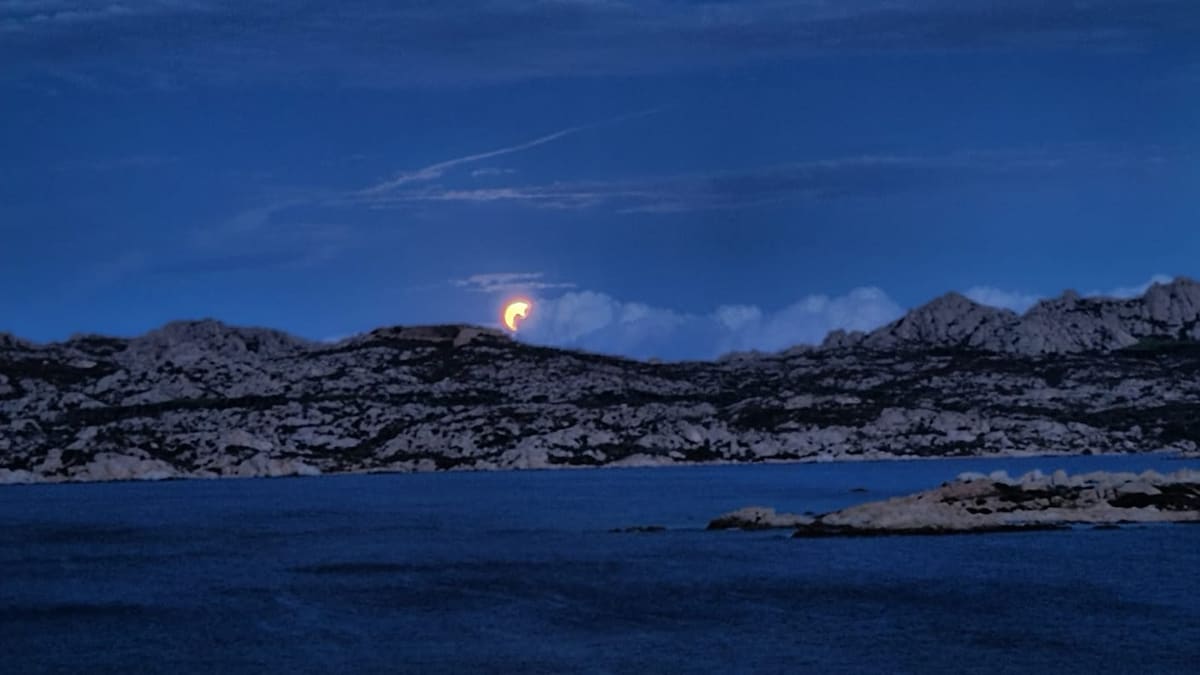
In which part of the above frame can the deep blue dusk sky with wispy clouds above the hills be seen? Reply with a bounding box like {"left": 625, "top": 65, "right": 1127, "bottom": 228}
{"left": 0, "top": 0, "right": 1200, "bottom": 358}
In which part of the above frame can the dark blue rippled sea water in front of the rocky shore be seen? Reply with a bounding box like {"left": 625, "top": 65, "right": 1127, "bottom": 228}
{"left": 0, "top": 456, "right": 1200, "bottom": 673}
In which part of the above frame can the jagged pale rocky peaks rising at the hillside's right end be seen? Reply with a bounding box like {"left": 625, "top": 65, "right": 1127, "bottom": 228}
{"left": 849, "top": 277, "right": 1200, "bottom": 354}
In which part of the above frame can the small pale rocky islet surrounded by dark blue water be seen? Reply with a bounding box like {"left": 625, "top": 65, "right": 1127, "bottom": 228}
{"left": 708, "top": 470, "right": 1200, "bottom": 537}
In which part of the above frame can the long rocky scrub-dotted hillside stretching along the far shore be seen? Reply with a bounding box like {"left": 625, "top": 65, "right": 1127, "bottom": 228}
{"left": 0, "top": 279, "right": 1200, "bottom": 482}
